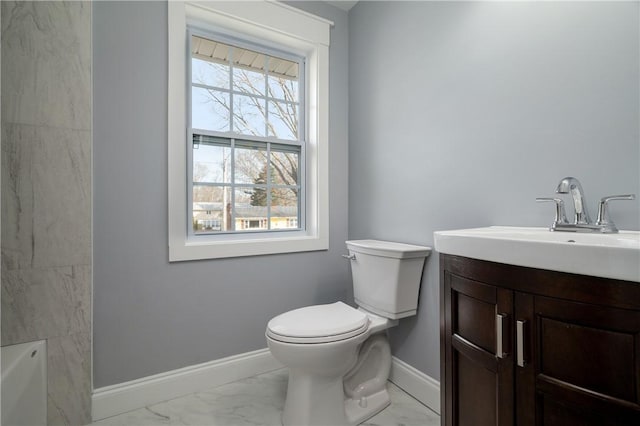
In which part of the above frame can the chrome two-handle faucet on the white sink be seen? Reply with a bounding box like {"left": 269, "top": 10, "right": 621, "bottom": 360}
{"left": 536, "top": 176, "right": 636, "bottom": 234}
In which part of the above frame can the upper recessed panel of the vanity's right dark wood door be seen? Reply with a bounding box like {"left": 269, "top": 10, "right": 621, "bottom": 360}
{"left": 535, "top": 297, "right": 640, "bottom": 404}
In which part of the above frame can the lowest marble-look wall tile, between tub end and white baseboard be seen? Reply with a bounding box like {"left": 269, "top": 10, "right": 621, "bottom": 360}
{"left": 47, "top": 332, "right": 91, "bottom": 426}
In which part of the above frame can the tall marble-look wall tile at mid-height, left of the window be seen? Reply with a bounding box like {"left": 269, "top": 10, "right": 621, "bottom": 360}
{"left": 2, "top": 124, "right": 91, "bottom": 270}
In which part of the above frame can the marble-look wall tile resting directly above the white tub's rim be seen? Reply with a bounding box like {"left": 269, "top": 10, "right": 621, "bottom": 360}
{"left": 1, "top": 266, "right": 91, "bottom": 346}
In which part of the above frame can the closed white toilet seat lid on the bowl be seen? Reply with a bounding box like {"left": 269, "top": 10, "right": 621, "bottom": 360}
{"left": 267, "top": 302, "right": 369, "bottom": 343}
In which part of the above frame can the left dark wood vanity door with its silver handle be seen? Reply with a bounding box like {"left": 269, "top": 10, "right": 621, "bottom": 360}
{"left": 441, "top": 271, "right": 514, "bottom": 426}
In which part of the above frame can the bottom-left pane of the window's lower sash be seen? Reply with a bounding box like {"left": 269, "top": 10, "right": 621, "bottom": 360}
{"left": 192, "top": 185, "right": 231, "bottom": 233}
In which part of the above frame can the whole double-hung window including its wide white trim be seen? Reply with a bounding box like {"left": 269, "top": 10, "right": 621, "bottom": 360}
{"left": 168, "top": 1, "right": 331, "bottom": 261}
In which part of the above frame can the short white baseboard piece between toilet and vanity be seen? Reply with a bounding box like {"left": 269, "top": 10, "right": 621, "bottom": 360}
{"left": 389, "top": 357, "right": 440, "bottom": 414}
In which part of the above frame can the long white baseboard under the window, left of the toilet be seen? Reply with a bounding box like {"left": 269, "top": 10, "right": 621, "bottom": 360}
{"left": 92, "top": 348, "right": 282, "bottom": 421}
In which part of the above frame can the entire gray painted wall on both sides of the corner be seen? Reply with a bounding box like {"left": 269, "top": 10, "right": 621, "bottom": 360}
{"left": 93, "top": 2, "right": 640, "bottom": 387}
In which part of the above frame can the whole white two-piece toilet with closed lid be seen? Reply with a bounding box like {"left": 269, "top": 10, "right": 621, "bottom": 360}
{"left": 266, "top": 240, "right": 431, "bottom": 426}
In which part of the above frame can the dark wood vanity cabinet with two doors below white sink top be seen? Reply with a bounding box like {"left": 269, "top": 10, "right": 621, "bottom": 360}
{"left": 440, "top": 254, "right": 640, "bottom": 426}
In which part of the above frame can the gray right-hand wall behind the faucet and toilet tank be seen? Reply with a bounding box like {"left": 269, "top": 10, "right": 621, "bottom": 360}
{"left": 349, "top": 2, "right": 640, "bottom": 378}
